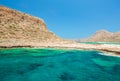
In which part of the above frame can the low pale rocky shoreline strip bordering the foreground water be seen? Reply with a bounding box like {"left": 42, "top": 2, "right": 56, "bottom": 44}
{"left": 0, "top": 43, "right": 120, "bottom": 57}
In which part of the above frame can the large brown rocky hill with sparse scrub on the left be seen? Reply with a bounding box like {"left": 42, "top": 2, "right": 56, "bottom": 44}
{"left": 0, "top": 6, "right": 64, "bottom": 46}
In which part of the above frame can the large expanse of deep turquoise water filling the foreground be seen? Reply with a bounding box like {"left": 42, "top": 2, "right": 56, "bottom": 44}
{"left": 0, "top": 48, "right": 120, "bottom": 81}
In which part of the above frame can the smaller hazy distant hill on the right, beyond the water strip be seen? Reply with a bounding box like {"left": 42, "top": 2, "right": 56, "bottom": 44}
{"left": 85, "top": 30, "right": 120, "bottom": 42}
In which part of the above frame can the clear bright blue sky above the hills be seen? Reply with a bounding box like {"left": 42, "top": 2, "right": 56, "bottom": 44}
{"left": 0, "top": 0, "right": 120, "bottom": 39}
